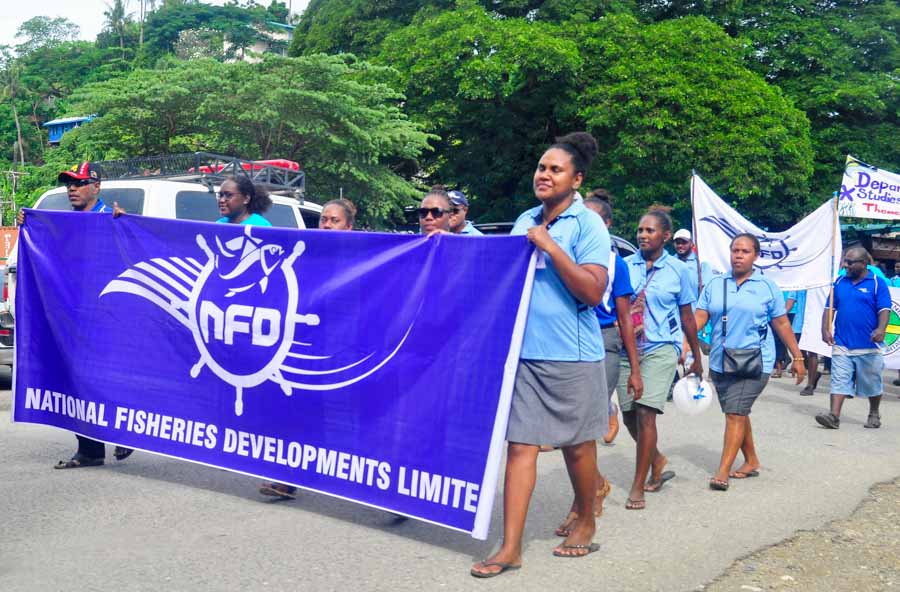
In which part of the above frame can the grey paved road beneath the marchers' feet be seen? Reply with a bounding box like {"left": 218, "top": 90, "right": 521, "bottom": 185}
{"left": 0, "top": 366, "right": 900, "bottom": 592}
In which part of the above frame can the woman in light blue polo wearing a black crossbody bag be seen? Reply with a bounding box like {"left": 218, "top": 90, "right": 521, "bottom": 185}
{"left": 696, "top": 233, "right": 806, "bottom": 491}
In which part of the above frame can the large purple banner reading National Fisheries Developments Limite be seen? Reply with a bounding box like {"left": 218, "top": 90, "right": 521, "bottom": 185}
{"left": 13, "top": 211, "right": 532, "bottom": 538}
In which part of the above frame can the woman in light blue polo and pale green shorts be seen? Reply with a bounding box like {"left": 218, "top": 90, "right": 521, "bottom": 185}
{"left": 617, "top": 206, "right": 703, "bottom": 510}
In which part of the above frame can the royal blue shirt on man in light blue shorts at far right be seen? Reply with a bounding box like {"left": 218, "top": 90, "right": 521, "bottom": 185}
{"left": 825, "top": 271, "right": 891, "bottom": 349}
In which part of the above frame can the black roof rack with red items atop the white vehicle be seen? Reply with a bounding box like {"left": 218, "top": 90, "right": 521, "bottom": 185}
{"left": 95, "top": 152, "right": 306, "bottom": 201}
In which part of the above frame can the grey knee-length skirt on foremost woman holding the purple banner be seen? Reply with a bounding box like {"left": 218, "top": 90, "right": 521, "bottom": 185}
{"left": 506, "top": 360, "right": 609, "bottom": 446}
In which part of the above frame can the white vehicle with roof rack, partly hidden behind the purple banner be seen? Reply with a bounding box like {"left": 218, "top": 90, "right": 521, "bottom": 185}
{"left": 0, "top": 171, "right": 322, "bottom": 374}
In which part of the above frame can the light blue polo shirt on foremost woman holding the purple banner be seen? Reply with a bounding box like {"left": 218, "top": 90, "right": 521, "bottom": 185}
{"left": 510, "top": 200, "right": 611, "bottom": 362}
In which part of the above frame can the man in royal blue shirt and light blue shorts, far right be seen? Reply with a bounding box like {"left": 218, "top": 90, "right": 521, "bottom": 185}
{"left": 816, "top": 247, "right": 891, "bottom": 430}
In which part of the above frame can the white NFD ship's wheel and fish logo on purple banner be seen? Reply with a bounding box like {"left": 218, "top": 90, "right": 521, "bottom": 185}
{"left": 100, "top": 226, "right": 413, "bottom": 415}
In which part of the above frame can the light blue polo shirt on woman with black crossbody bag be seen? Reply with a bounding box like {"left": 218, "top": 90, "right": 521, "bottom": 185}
{"left": 697, "top": 269, "right": 787, "bottom": 374}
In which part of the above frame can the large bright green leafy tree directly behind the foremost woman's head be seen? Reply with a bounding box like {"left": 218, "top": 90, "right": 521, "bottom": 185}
{"left": 380, "top": 4, "right": 812, "bottom": 224}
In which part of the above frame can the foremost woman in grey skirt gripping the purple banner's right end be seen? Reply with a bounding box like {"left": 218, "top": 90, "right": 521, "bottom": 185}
{"left": 470, "top": 132, "right": 610, "bottom": 578}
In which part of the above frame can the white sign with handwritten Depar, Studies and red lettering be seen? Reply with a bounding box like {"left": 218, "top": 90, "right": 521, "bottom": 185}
{"left": 838, "top": 156, "right": 900, "bottom": 220}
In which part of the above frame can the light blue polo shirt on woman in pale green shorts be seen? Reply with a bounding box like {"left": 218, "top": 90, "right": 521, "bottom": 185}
{"left": 625, "top": 250, "right": 697, "bottom": 355}
